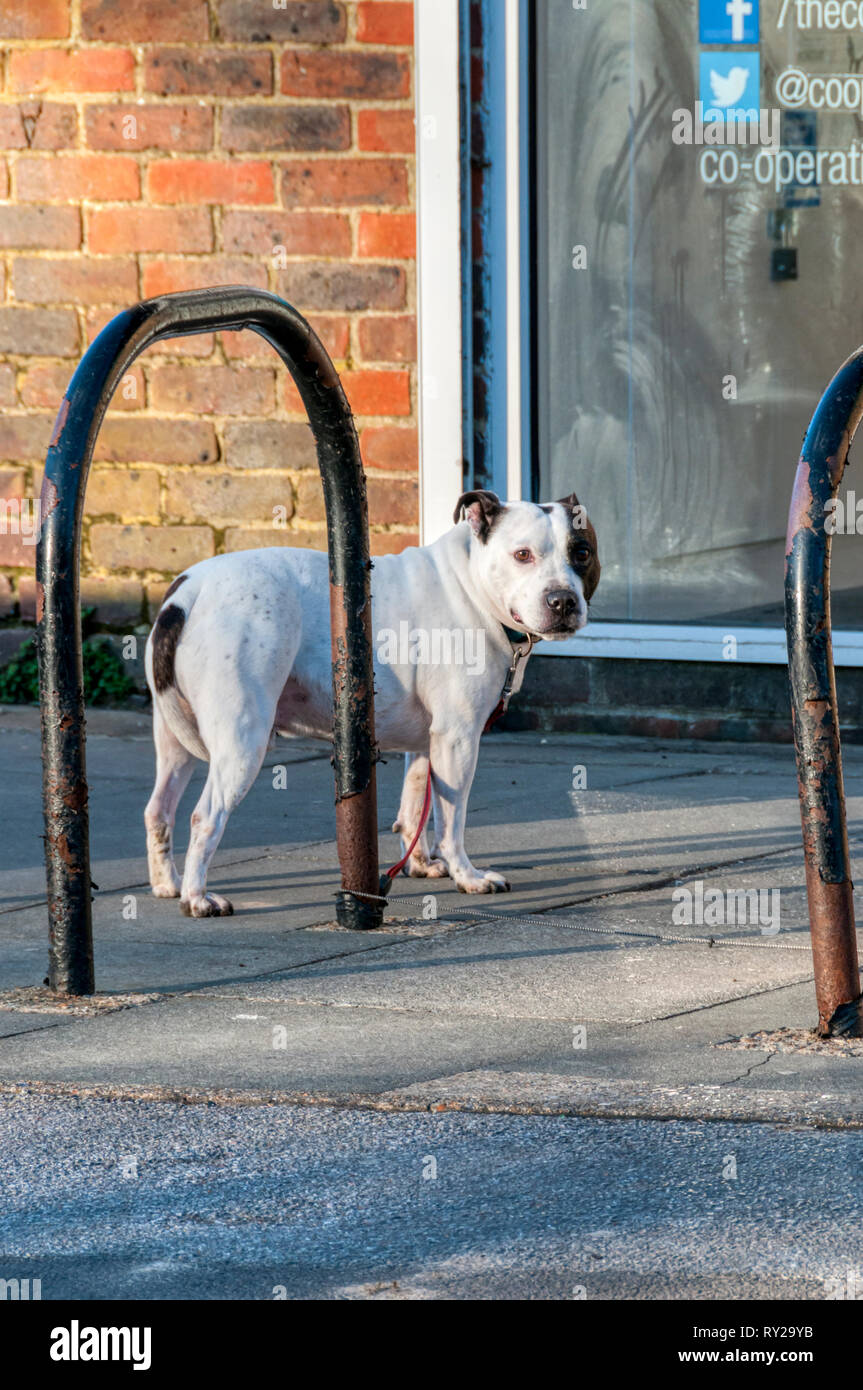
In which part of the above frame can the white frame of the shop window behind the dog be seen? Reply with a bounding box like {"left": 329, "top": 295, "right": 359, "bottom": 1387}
{"left": 414, "top": 0, "right": 863, "bottom": 666}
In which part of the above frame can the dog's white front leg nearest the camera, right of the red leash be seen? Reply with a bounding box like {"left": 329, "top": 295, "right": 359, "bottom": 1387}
{"left": 429, "top": 727, "right": 510, "bottom": 892}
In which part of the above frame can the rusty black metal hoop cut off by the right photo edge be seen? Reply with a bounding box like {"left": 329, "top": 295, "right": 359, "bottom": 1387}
{"left": 785, "top": 348, "right": 863, "bottom": 1037}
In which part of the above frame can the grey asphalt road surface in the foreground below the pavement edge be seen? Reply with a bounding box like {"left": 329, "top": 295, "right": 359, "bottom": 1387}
{"left": 0, "top": 1094, "right": 863, "bottom": 1300}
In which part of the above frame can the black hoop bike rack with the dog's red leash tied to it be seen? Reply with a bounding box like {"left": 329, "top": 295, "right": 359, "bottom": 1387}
{"left": 36, "top": 285, "right": 382, "bottom": 994}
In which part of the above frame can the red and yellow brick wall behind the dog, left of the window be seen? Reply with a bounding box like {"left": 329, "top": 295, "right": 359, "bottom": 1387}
{"left": 0, "top": 0, "right": 417, "bottom": 626}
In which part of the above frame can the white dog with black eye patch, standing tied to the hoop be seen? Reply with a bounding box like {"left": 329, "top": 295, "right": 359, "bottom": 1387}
{"left": 145, "top": 492, "right": 599, "bottom": 917}
